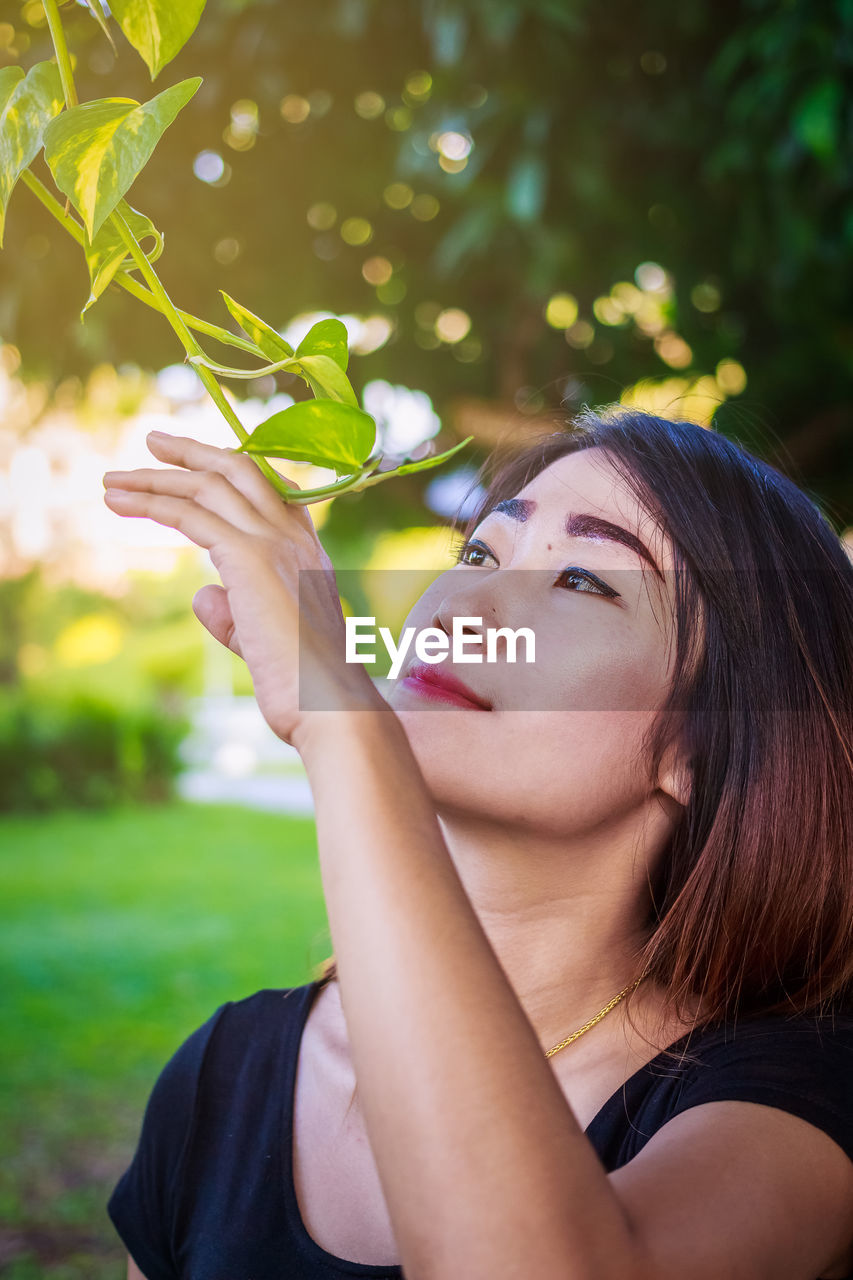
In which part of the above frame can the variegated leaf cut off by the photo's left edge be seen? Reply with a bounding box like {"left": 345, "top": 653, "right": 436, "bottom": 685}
{"left": 0, "top": 63, "right": 63, "bottom": 244}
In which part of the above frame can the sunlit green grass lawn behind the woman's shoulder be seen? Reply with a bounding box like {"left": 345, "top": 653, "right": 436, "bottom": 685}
{"left": 0, "top": 803, "right": 330, "bottom": 1280}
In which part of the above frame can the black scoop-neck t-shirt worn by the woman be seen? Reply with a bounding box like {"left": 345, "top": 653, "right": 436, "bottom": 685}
{"left": 108, "top": 983, "right": 853, "bottom": 1280}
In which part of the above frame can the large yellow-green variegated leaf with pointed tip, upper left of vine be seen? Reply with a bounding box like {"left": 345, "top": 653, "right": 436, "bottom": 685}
{"left": 45, "top": 76, "right": 201, "bottom": 241}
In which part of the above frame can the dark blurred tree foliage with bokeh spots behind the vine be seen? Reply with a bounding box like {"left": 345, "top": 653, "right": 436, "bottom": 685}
{"left": 0, "top": 0, "right": 853, "bottom": 524}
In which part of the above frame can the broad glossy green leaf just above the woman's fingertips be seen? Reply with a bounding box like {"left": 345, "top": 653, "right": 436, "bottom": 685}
{"left": 236, "top": 399, "right": 377, "bottom": 475}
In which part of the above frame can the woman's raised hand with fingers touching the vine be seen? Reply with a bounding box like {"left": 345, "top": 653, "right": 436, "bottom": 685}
{"left": 104, "top": 431, "right": 384, "bottom": 746}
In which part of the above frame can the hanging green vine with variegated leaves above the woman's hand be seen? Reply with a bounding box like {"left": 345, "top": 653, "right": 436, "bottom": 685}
{"left": 0, "top": 0, "right": 470, "bottom": 504}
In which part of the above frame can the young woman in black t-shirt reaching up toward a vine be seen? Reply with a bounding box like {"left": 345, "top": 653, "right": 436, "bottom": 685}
{"left": 105, "top": 410, "right": 853, "bottom": 1280}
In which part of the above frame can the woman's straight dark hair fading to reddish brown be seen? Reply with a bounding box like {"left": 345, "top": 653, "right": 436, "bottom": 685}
{"left": 315, "top": 407, "right": 853, "bottom": 1025}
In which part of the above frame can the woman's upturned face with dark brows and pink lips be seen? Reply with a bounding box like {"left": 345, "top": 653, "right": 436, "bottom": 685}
{"left": 388, "top": 448, "right": 674, "bottom": 835}
